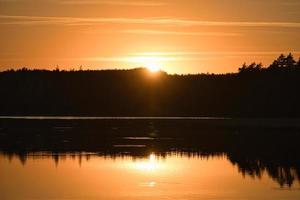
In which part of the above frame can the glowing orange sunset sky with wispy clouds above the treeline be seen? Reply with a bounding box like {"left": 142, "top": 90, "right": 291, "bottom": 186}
{"left": 0, "top": 0, "right": 300, "bottom": 74}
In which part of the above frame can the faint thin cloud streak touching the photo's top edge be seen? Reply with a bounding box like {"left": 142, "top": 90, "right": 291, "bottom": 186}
{"left": 60, "top": 0, "right": 167, "bottom": 7}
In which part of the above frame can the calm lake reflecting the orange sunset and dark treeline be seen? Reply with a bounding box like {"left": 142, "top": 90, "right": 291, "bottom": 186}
{"left": 0, "top": 117, "right": 300, "bottom": 200}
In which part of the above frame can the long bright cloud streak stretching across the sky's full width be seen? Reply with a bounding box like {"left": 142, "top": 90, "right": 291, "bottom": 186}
{"left": 0, "top": 15, "right": 300, "bottom": 28}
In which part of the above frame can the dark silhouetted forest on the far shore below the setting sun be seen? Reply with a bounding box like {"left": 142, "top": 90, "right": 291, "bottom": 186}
{"left": 0, "top": 54, "right": 300, "bottom": 118}
